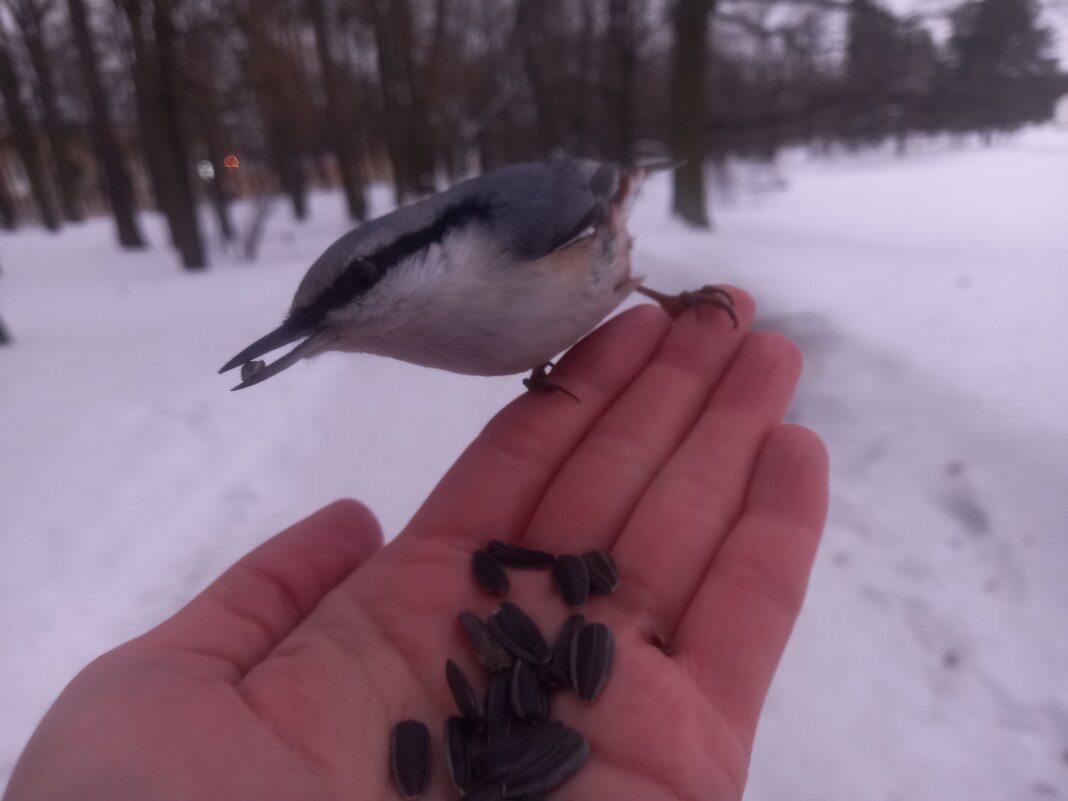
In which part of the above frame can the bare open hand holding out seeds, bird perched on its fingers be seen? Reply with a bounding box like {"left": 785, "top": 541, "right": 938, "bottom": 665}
{"left": 5, "top": 290, "right": 827, "bottom": 801}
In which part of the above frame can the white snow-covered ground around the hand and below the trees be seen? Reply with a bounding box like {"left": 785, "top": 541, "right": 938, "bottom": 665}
{"left": 0, "top": 129, "right": 1068, "bottom": 801}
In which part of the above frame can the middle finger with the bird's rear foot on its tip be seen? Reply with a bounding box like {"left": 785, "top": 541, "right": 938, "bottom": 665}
{"left": 523, "top": 288, "right": 755, "bottom": 553}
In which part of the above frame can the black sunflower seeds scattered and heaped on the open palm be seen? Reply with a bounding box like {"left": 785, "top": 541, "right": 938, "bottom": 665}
{"left": 390, "top": 540, "right": 619, "bottom": 801}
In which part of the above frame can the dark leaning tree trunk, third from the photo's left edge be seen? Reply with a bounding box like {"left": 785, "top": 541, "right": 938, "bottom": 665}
{"left": 67, "top": 0, "right": 144, "bottom": 248}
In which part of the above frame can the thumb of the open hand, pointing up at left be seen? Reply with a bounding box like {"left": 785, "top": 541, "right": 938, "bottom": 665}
{"left": 135, "top": 501, "right": 382, "bottom": 681}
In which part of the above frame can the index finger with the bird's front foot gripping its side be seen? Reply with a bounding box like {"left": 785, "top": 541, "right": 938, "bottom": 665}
{"left": 407, "top": 305, "right": 670, "bottom": 539}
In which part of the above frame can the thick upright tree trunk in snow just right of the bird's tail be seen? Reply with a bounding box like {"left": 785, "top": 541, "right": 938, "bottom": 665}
{"left": 671, "top": 0, "right": 716, "bottom": 229}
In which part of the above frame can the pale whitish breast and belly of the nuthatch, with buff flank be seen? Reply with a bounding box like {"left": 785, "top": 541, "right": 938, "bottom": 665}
{"left": 328, "top": 216, "right": 633, "bottom": 376}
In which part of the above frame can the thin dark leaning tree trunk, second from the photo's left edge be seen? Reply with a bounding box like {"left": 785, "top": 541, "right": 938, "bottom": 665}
{"left": 12, "top": 0, "right": 84, "bottom": 222}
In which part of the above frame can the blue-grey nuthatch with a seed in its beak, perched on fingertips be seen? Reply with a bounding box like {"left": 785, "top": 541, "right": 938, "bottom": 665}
{"left": 219, "top": 159, "right": 734, "bottom": 394}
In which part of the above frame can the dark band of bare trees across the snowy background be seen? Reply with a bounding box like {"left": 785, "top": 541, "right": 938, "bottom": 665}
{"left": 0, "top": 0, "right": 1068, "bottom": 269}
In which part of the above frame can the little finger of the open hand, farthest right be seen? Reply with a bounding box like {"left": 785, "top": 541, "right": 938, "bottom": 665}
{"left": 676, "top": 425, "right": 828, "bottom": 743}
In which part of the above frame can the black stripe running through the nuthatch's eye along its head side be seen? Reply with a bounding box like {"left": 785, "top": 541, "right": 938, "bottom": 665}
{"left": 286, "top": 199, "right": 492, "bottom": 330}
